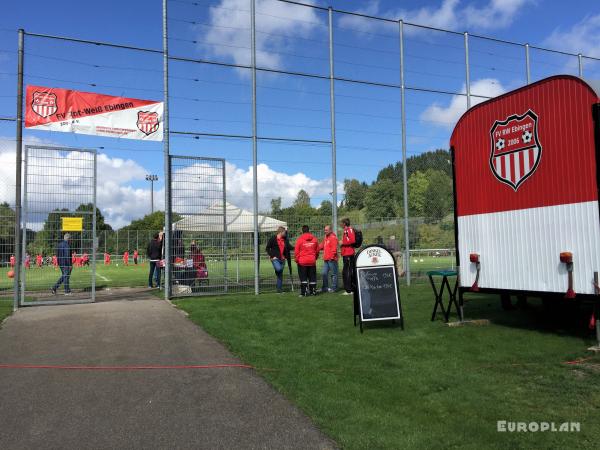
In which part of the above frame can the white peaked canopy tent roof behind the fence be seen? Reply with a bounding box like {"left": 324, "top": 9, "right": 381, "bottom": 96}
{"left": 173, "top": 202, "right": 287, "bottom": 233}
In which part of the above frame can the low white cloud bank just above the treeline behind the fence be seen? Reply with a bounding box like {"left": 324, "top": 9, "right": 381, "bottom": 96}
{"left": 0, "top": 138, "right": 343, "bottom": 229}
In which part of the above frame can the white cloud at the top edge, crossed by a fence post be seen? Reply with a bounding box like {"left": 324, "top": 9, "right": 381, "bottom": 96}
{"left": 200, "top": 0, "right": 324, "bottom": 68}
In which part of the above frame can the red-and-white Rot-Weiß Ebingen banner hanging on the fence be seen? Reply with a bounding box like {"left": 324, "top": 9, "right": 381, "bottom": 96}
{"left": 25, "top": 86, "right": 164, "bottom": 141}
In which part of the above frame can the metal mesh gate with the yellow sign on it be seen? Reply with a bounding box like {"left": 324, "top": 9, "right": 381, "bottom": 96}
{"left": 20, "top": 145, "right": 96, "bottom": 306}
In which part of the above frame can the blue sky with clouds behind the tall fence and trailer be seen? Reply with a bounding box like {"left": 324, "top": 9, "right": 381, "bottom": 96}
{"left": 0, "top": 0, "right": 600, "bottom": 226}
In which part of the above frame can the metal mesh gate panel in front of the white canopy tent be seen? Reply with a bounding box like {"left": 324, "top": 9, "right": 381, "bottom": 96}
{"left": 169, "top": 155, "right": 230, "bottom": 297}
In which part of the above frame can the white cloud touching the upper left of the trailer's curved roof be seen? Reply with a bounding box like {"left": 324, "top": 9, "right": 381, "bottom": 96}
{"left": 420, "top": 78, "right": 506, "bottom": 130}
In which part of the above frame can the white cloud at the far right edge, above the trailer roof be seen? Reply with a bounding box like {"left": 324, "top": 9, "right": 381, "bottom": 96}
{"left": 543, "top": 14, "right": 600, "bottom": 58}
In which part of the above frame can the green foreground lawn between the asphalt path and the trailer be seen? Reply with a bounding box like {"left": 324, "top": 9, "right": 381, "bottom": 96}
{"left": 177, "top": 284, "right": 600, "bottom": 449}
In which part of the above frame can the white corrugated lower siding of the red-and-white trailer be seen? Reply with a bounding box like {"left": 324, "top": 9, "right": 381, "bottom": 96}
{"left": 458, "top": 201, "right": 600, "bottom": 294}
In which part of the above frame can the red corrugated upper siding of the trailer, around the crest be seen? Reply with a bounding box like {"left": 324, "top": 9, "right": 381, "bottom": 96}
{"left": 451, "top": 77, "right": 598, "bottom": 216}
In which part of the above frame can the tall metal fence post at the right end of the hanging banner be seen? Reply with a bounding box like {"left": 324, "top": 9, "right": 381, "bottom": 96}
{"left": 163, "top": 0, "right": 171, "bottom": 300}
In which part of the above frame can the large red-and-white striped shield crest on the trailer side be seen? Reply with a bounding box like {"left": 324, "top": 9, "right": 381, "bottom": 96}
{"left": 490, "top": 110, "right": 542, "bottom": 192}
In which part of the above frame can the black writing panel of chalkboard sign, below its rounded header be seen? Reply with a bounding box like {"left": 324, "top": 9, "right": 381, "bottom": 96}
{"left": 357, "top": 266, "right": 400, "bottom": 322}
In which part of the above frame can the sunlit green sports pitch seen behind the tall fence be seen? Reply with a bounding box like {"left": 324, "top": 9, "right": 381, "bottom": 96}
{"left": 0, "top": 256, "right": 453, "bottom": 291}
